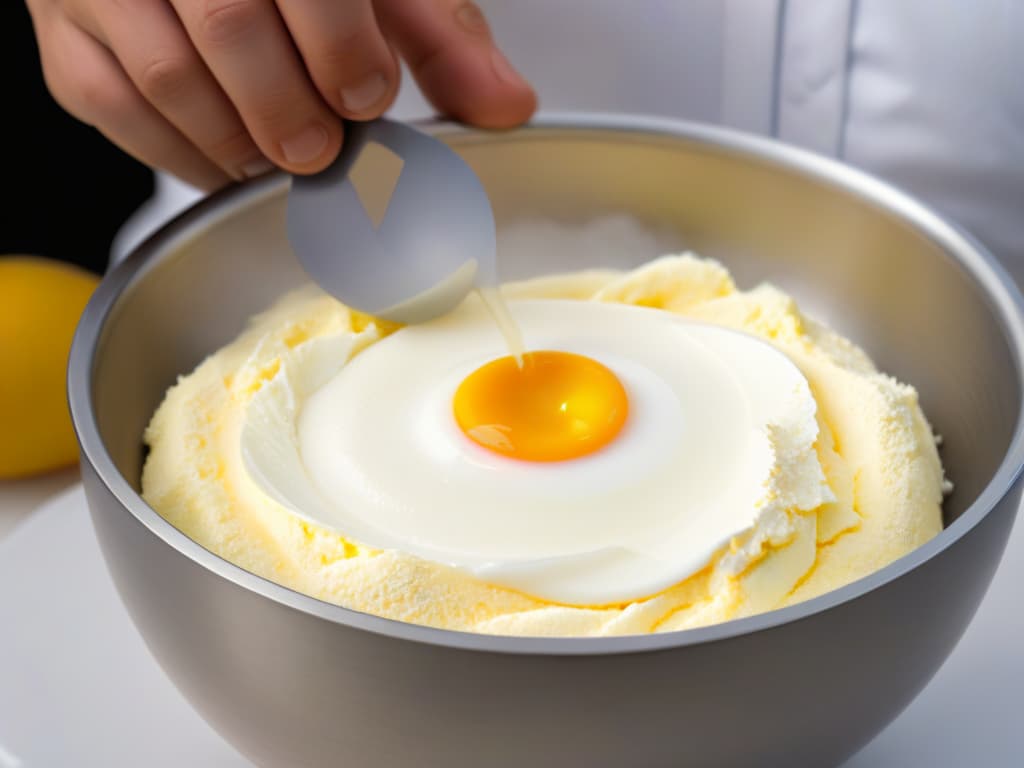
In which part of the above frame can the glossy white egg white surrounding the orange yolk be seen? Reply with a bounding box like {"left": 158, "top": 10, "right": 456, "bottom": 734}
{"left": 242, "top": 300, "right": 823, "bottom": 605}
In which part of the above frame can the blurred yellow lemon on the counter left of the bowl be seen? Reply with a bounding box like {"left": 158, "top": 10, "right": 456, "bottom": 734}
{"left": 0, "top": 256, "right": 97, "bottom": 479}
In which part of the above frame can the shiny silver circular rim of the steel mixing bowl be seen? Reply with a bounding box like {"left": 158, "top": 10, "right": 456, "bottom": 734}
{"left": 68, "top": 113, "right": 1024, "bottom": 656}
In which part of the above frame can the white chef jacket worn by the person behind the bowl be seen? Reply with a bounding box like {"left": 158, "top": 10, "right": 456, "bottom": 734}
{"left": 115, "top": 0, "right": 1024, "bottom": 283}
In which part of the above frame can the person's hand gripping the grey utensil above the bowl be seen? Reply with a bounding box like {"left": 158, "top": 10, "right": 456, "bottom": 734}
{"left": 27, "top": 0, "right": 537, "bottom": 189}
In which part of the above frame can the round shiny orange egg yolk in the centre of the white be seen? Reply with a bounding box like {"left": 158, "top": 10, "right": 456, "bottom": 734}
{"left": 454, "top": 351, "right": 629, "bottom": 462}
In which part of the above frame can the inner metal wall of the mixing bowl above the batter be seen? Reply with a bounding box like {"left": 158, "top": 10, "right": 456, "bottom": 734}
{"left": 92, "top": 127, "right": 1021, "bottom": 523}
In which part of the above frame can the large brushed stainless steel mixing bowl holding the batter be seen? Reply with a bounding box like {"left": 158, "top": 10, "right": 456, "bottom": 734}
{"left": 70, "top": 117, "right": 1024, "bottom": 768}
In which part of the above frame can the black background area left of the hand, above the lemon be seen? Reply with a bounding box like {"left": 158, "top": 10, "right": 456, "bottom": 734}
{"left": 0, "top": 0, "right": 153, "bottom": 272}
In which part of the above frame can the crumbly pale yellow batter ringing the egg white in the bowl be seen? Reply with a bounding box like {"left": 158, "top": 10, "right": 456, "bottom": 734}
{"left": 142, "top": 255, "right": 945, "bottom": 636}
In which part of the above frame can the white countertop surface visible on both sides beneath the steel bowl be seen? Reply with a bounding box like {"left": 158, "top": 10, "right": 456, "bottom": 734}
{"left": 0, "top": 471, "right": 1024, "bottom": 768}
